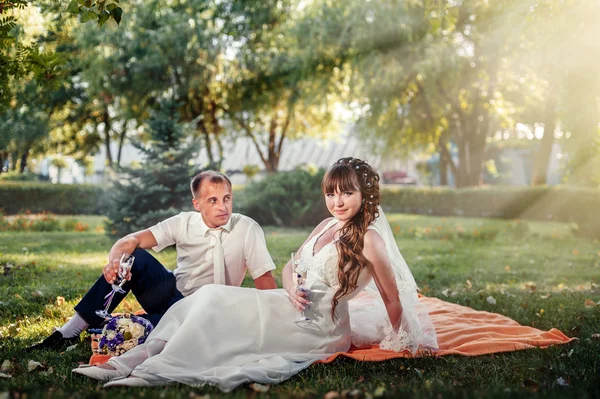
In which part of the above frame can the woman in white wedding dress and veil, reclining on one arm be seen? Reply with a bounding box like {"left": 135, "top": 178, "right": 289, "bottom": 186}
{"left": 73, "top": 158, "right": 437, "bottom": 392}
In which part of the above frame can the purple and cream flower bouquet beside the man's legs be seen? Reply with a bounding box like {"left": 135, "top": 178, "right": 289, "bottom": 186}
{"left": 98, "top": 315, "right": 154, "bottom": 356}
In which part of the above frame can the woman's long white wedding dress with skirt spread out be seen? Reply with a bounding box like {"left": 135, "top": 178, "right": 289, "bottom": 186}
{"left": 109, "top": 214, "right": 435, "bottom": 392}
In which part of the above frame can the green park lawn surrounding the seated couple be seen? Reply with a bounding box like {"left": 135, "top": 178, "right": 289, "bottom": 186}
{"left": 0, "top": 215, "right": 600, "bottom": 398}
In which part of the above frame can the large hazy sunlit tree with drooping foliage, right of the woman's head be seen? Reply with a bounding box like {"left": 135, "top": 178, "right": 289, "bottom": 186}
{"left": 310, "top": 0, "right": 532, "bottom": 187}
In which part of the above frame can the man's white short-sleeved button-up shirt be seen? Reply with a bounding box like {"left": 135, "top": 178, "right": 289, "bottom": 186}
{"left": 149, "top": 212, "right": 275, "bottom": 296}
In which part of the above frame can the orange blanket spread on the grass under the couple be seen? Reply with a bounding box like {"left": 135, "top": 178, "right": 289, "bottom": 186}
{"left": 90, "top": 296, "right": 575, "bottom": 364}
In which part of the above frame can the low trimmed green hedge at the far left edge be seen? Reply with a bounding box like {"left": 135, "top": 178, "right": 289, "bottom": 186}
{"left": 0, "top": 181, "right": 103, "bottom": 215}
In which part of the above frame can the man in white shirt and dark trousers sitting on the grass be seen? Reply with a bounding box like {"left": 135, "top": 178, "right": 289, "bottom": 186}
{"left": 28, "top": 171, "right": 277, "bottom": 350}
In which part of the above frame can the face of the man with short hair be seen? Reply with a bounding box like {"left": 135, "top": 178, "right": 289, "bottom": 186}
{"left": 192, "top": 182, "right": 233, "bottom": 229}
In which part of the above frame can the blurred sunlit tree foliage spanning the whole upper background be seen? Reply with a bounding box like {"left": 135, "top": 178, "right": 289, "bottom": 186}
{"left": 0, "top": 0, "right": 600, "bottom": 234}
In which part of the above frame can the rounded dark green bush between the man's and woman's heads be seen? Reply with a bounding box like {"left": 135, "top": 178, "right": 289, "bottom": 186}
{"left": 234, "top": 168, "right": 329, "bottom": 227}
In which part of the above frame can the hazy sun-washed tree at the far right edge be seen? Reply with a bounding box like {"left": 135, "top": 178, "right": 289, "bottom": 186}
{"left": 523, "top": 0, "right": 600, "bottom": 185}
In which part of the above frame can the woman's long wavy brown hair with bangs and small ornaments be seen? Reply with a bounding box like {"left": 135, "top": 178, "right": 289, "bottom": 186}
{"left": 321, "top": 157, "right": 380, "bottom": 319}
